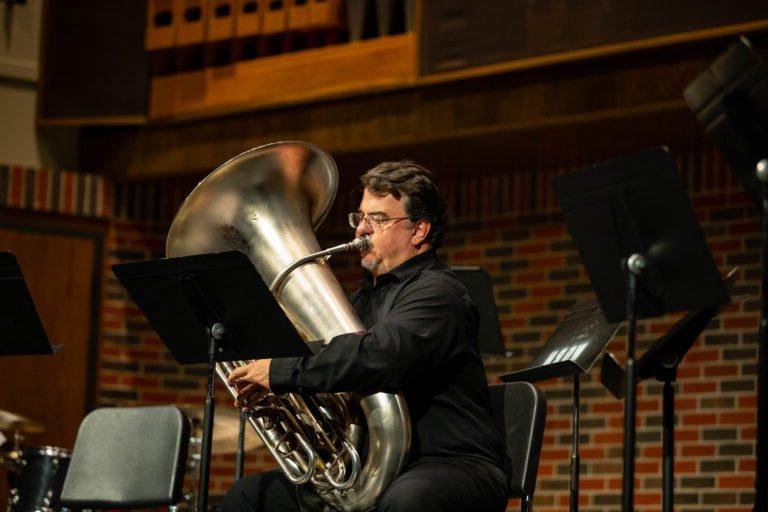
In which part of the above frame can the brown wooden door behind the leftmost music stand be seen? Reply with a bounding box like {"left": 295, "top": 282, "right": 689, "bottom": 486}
{"left": 0, "top": 216, "right": 102, "bottom": 449}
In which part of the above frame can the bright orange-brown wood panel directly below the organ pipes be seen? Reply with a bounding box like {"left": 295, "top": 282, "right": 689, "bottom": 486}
{"left": 149, "top": 32, "right": 416, "bottom": 120}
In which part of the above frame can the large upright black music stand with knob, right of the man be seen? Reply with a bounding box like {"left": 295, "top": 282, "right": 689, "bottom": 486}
{"left": 554, "top": 148, "right": 729, "bottom": 512}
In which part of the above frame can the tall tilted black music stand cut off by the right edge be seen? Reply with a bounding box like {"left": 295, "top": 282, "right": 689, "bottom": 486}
{"left": 683, "top": 37, "right": 768, "bottom": 510}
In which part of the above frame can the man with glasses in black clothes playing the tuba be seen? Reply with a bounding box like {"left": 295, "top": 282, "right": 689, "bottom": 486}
{"left": 223, "top": 161, "right": 507, "bottom": 512}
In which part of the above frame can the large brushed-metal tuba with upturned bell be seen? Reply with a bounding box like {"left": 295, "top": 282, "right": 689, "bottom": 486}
{"left": 166, "top": 142, "right": 411, "bottom": 511}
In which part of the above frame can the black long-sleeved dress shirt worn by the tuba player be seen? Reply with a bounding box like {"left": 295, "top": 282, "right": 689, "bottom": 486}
{"left": 269, "top": 251, "right": 504, "bottom": 478}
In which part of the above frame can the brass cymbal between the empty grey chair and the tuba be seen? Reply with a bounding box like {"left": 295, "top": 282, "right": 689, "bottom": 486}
{"left": 175, "top": 404, "right": 262, "bottom": 455}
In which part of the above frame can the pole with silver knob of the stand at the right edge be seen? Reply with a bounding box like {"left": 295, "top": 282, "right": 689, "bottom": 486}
{"left": 755, "top": 159, "right": 768, "bottom": 510}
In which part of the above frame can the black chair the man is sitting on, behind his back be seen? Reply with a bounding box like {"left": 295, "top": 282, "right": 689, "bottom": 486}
{"left": 490, "top": 382, "right": 547, "bottom": 512}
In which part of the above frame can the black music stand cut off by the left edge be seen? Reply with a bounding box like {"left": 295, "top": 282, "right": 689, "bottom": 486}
{"left": 0, "top": 252, "right": 61, "bottom": 356}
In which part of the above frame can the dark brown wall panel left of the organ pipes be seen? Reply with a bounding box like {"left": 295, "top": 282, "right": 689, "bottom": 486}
{"left": 37, "top": 0, "right": 149, "bottom": 124}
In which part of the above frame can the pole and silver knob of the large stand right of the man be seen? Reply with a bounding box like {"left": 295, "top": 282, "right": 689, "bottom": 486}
{"left": 621, "top": 253, "right": 645, "bottom": 512}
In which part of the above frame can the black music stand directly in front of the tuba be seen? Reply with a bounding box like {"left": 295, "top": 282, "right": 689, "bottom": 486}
{"left": 112, "top": 251, "right": 312, "bottom": 512}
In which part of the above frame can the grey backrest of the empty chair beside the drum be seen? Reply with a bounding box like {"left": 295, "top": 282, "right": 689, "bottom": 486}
{"left": 61, "top": 406, "right": 189, "bottom": 509}
